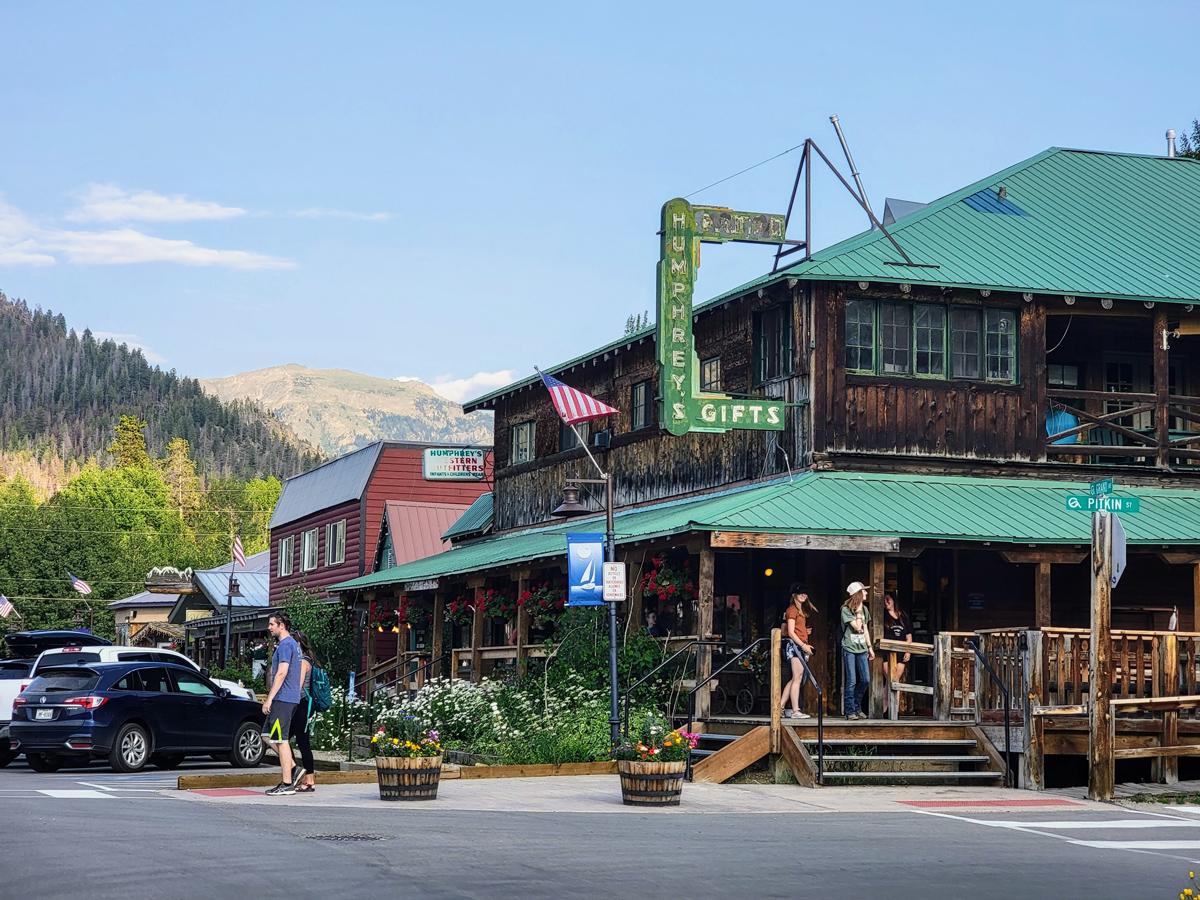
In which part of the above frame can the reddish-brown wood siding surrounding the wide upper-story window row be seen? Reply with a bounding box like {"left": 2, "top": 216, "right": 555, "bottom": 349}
{"left": 812, "top": 283, "right": 1045, "bottom": 460}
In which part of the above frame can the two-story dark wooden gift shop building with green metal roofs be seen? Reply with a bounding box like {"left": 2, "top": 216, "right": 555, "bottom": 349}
{"left": 332, "top": 149, "right": 1200, "bottom": 787}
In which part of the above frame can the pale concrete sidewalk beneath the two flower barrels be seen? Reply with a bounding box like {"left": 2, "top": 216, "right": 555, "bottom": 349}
{"left": 176, "top": 773, "right": 1106, "bottom": 815}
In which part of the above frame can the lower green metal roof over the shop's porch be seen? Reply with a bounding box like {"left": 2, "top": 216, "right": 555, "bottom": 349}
{"left": 330, "top": 472, "right": 1200, "bottom": 590}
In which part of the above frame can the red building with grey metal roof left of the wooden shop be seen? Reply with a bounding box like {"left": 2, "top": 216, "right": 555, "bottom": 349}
{"left": 270, "top": 442, "right": 492, "bottom": 606}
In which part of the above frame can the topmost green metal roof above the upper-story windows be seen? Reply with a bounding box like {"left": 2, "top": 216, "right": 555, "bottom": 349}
{"left": 463, "top": 148, "right": 1200, "bottom": 412}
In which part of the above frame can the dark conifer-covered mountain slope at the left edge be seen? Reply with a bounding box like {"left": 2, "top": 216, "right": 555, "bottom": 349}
{"left": 0, "top": 293, "right": 322, "bottom": 479}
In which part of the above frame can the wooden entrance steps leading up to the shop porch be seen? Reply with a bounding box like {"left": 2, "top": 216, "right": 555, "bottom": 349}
{"left": 692, "top": 719, "right": 1004, "bottom": 786}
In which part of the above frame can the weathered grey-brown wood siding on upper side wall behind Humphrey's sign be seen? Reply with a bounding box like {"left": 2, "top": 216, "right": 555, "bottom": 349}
{"left": 496, "top": 288, "right": 810, "bottom": 529}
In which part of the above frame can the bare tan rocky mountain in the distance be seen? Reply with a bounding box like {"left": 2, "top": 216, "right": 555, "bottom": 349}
{"left": 200, "top": 365, "right": 492, "bottom": 456}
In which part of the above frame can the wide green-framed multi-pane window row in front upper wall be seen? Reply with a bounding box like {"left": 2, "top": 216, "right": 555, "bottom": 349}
{"left": 846, "top": 298, "right": 1016, "bottom": 384}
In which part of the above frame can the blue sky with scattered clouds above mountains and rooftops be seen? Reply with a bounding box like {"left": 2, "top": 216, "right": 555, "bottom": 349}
{"left": 0, "top": 0, "right": 1200, "bottom": 400}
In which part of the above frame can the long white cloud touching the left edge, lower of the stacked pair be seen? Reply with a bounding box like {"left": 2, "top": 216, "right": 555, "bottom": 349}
{"left": 0, "top": 200, "right": 295, "bottom": 269}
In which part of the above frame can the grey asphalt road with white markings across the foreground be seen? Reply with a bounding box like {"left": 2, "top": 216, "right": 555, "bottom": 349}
{"left": 0, "top": 763, "right": 1200, "bottom": 900}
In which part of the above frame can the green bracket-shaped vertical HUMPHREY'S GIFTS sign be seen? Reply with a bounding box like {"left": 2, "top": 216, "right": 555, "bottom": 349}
{"left": 658, "top": 198, "right": 786, "bottom": 434}
